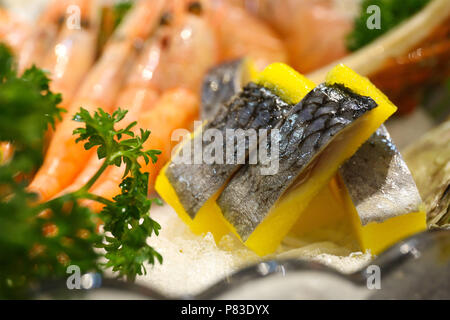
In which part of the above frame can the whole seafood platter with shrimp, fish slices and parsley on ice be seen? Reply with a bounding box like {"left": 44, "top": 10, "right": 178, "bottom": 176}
{"left": 0, "top": 0, "right": 450, "bottom": 298}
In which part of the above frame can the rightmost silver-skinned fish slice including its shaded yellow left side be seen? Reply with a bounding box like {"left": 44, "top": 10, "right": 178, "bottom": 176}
{"left": 290, "top": 125, "right": 427, "bottom": 255}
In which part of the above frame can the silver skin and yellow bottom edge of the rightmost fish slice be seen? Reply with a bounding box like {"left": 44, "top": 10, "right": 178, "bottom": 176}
{"left": 339, "top": 126, "right": 427, "bottom": 254}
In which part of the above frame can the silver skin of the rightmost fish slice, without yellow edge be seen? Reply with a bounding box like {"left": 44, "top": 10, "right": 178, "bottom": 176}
{"left": 339, "top": 125, "right": 422, "bottom": 225}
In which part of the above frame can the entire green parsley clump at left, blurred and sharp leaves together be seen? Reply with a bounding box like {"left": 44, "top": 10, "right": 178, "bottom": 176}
{"left": 0, "top": 45, "right": 162, "bottom": 298}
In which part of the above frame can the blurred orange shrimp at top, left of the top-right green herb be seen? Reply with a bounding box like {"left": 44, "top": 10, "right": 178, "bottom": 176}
{"left": 234, "top": 0, "right": 358, "bottom": 73}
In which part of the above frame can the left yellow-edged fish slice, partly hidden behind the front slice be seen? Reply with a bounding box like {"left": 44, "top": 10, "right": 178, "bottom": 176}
{"left": 156, "top": 63, "right": 313, "bottom": 241}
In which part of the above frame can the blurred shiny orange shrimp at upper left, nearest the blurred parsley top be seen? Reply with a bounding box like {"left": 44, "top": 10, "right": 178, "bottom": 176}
{"left": 42, "top": 0, "right": 100, "bottom": 106}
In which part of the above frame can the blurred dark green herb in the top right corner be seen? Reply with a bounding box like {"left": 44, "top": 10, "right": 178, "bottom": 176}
{"left": 347, "top": 0, "right": 430, "bottom": 51}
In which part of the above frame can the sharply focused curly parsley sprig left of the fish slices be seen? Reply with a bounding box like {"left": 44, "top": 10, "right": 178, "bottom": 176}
{"left": 74, "top": 109, "right": 162, "bottom": 280}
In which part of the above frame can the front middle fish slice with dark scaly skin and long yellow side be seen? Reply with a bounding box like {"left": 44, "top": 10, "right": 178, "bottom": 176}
{"left": 217, "top": 65, "right": 396, "bottom": 255}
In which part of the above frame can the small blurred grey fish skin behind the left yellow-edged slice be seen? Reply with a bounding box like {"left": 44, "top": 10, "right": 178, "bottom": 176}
{"left": 201, "top": 59, "right": 244, "bottom": 120}
